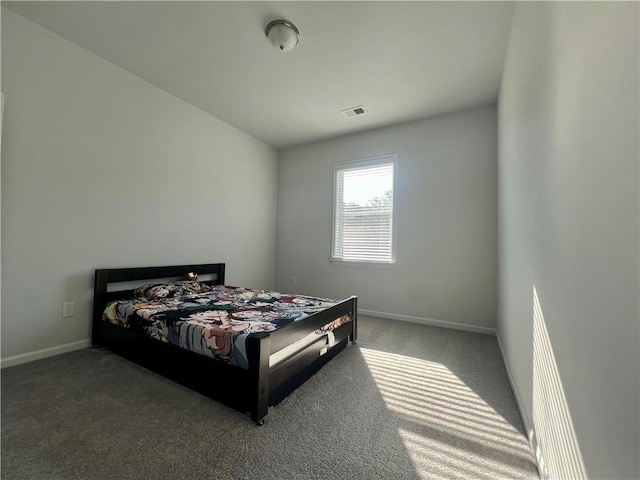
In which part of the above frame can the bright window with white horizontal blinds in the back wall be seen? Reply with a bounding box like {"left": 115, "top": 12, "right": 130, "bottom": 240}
{"left": 331, "top": 155, "right": 396, "bottom": 263}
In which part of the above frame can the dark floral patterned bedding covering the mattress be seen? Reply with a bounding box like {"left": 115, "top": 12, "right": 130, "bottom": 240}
{"left": 102, "top": 285, "right": 350, "bottom": 369}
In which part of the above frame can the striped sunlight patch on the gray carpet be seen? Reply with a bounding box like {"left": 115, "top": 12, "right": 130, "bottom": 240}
{"left": 360, "top": 348, "right": 536, "bottom": 479}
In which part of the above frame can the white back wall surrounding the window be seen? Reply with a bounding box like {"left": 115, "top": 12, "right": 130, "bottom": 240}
{"left": 276, "top": 106, "right": 497, "bottom": 327}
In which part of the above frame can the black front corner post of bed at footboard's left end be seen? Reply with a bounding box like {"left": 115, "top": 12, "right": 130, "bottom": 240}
{"left": 247, "top": 333, "right": 271, "bottom": 425}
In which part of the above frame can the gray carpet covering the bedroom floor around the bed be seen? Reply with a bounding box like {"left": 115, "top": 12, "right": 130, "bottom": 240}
{"left": 1, "top": 316, "right": 538, "bottom": 480}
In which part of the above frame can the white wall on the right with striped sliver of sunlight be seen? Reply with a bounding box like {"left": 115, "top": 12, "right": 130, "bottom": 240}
{"left": 498, "top": 2, "right": 640, "bottom": 479}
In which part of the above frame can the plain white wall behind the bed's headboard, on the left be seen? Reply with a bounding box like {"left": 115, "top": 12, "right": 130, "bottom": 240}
{"left": 2, "top": 9, "right": 277, "bottom": 358}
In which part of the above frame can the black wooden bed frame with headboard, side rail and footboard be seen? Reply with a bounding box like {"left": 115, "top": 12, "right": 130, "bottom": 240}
{"left": 91, "top": 263, "right": 357, "bottom": 425}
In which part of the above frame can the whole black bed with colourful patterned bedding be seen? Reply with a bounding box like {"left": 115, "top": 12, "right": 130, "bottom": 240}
{"left": 91, "top": 263, "right": 357, "bottom": 425}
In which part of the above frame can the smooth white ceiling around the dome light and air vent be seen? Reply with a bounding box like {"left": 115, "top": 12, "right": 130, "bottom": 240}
{"left": 2, "top": 1, "right": 513, "bottom": 148}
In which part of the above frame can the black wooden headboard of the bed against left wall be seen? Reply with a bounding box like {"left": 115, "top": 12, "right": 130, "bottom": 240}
{"left": 93, "top": 263, "right": 225, "bottom": 344}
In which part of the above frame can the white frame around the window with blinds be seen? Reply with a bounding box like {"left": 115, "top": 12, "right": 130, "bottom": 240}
{"left": 329, "top": 153, "right": 398, "bottom": 268}
